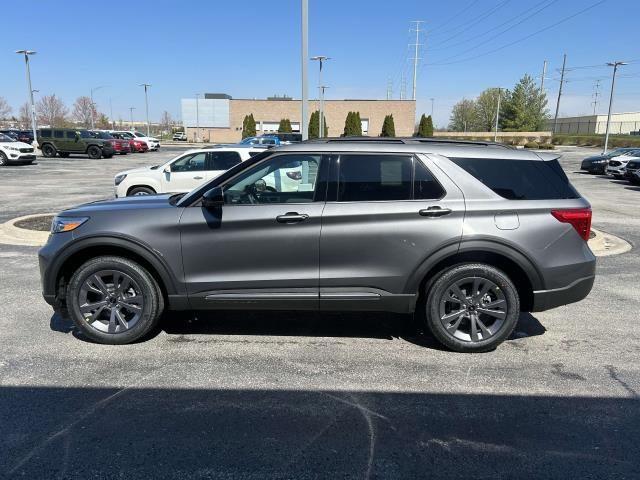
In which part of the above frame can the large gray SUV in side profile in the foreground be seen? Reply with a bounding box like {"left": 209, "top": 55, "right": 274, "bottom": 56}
{"left": 39, "top": 138, "right": 595, "bottom": 352}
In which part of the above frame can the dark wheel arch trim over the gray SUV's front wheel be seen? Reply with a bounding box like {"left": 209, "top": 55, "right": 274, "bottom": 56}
{"left": 44, "top": 236, "right": 179, "bottom": 299}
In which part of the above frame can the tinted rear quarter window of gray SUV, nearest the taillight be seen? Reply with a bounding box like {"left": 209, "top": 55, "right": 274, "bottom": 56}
{"left": 451, "top": 158, "right": 580, "bottom": 200}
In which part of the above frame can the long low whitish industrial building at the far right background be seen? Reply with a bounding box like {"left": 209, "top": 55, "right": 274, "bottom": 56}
{"left": 547, "top": 112, "right": 640, "bottom": 135}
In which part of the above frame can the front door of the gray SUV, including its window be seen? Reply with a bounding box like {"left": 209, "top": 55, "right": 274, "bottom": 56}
{"left": 180, "top": 153, "right": 326, "bottom": 309}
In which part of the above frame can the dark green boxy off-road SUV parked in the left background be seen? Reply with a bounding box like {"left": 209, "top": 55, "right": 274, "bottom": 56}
{"left": 38, "top": 128, "right": 115, "bottom": 159}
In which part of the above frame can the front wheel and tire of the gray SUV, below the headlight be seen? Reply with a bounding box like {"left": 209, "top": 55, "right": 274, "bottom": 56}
{"left": 66, "top": 256, "right": 164, "bottom": 345}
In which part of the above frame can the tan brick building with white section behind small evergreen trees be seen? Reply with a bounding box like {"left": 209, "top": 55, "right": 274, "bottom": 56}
{"left": 182, "top": 94, "right": 416, "bottom": 143}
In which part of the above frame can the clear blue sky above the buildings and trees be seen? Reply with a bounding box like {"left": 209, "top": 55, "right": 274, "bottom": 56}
{"left": 0, "top": 0, "right": 640, "bottom": 125}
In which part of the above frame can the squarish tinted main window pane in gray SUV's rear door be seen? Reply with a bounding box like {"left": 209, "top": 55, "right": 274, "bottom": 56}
{"left": 338, "top": 154, "right": 412, "bottom": 202}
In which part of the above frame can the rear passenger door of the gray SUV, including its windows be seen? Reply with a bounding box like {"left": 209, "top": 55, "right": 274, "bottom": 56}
{"left": 320, "top": 153, "right": 464, "bottom": 312}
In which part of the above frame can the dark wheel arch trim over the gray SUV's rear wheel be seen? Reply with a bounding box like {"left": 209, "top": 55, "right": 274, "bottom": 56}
{"left": 407, "top": 240, "right": 544, "bottom": 311}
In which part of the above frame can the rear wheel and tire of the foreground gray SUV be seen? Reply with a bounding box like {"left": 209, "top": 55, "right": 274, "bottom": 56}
{"left": 425, "top": 263, "right": 520, "bottom": 353}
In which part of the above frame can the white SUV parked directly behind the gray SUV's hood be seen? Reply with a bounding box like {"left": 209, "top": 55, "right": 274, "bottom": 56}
{"left": 115, "top": 146, "right": 264, "bottom": 197}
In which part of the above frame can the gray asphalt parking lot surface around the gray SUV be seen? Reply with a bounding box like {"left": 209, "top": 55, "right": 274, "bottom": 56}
{"left": 0, "top": 147, "right": 640, "bottom": 479}
